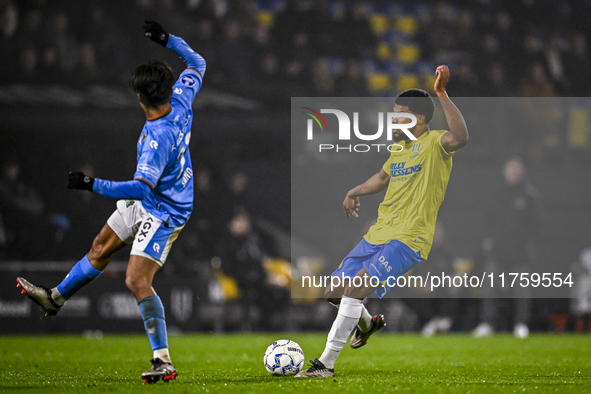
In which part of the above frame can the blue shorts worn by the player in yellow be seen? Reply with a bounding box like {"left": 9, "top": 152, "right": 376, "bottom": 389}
{"left": 332, "top": 239, "right": 424, "bottom": 298}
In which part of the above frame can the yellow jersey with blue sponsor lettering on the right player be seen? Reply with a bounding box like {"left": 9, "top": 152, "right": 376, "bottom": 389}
{"left": 364, "top": 130, "right": 453, "bottom": 259}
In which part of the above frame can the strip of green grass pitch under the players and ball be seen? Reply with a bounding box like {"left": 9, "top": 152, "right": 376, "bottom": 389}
{"left": 0, "top": 333, "right": 591, "bottom": 393}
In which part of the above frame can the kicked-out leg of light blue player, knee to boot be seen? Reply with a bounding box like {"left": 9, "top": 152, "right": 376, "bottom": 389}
{"left": 16, "top": 224, "right": 125, "bottom": 316}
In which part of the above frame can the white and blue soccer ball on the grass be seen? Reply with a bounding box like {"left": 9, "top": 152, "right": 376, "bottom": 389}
{"left": 263, "top": 339, "right": 304, "bottom": 376}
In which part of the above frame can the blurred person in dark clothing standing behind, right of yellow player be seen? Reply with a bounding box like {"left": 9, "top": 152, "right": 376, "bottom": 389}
{"left": 474, "top": 157, "right": 539, "bottom": 338}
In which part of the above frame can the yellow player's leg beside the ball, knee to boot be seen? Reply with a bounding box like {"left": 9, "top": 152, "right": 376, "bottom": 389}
{"left": 296, "top": 268, "right": 375, "bottom": 378}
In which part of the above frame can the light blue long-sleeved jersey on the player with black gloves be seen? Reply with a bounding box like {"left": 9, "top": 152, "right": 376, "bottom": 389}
{"left": 93, "top": 34, "right": 205, "bottom": 227}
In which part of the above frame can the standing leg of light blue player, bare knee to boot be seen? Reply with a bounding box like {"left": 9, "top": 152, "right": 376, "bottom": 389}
{"left": 125, "top": 254, "right": 177, "bottom": 383}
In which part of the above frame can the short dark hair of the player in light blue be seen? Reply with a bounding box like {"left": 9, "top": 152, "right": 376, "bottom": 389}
{"left": 130, "top": 60, "right": 174, "bottom": 107}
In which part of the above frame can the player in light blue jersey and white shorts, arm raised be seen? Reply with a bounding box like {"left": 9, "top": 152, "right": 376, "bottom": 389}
{"left": 17, "top": 21, "right": 205, "bottom": 383}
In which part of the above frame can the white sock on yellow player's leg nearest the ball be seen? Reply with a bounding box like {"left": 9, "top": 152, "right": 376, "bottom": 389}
{"left": 319, "top": 296, "right": 363, "bottom": 369}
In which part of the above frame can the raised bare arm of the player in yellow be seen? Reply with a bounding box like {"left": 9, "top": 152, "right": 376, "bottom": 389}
{"left": 435, "top": 66, "right": 468, "bottom": 153}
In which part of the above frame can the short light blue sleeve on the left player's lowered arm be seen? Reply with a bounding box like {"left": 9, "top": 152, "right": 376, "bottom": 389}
{"left": 133, "top": 129, "right": 172, "bottom": 189}
